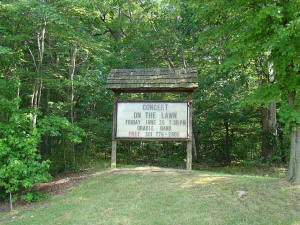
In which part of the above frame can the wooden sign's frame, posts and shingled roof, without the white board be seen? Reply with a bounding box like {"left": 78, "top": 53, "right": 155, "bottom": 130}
{"left": 106, "top": 68, "right": 198, "bottom": 170}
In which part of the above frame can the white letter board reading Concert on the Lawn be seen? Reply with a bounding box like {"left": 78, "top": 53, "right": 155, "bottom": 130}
{"left": 115, "top": 101, "right": 189, "bottom": 139}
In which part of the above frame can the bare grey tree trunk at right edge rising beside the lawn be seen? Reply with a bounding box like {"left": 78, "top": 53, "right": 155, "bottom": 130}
{"left": 288, "top": 124, "right": 300, "bottom": 184}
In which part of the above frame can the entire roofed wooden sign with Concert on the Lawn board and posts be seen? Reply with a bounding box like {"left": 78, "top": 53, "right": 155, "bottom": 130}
{"left": 106, "top": 68, "right": 198, "bottom": 170}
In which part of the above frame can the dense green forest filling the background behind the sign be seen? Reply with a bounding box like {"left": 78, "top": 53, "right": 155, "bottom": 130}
{"left": 0, "top": 0, "right": 300, "bottom": 200}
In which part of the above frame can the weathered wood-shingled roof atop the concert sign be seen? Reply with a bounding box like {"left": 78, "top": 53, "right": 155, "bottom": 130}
{"left": 106, "top": 68, "right": 198, "bottom": 92}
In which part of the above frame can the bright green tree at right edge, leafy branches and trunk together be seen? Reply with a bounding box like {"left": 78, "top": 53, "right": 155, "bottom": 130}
{"left": 191, "top": 0, "right": 300, "bottom": 183}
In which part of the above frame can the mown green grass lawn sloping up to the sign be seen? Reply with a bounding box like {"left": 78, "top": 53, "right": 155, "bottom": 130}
{"left": 0, "top": 168, "right": 300, "bottom": 225}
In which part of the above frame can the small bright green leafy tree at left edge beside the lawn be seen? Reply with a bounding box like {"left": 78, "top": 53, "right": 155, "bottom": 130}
{"left": 0, "top": 79, "right": 51, "bottom": 205}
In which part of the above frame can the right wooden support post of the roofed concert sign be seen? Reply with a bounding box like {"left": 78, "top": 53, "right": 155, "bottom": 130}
{"left": 186, "top": 92, "right": 193, "bottom": 170}
